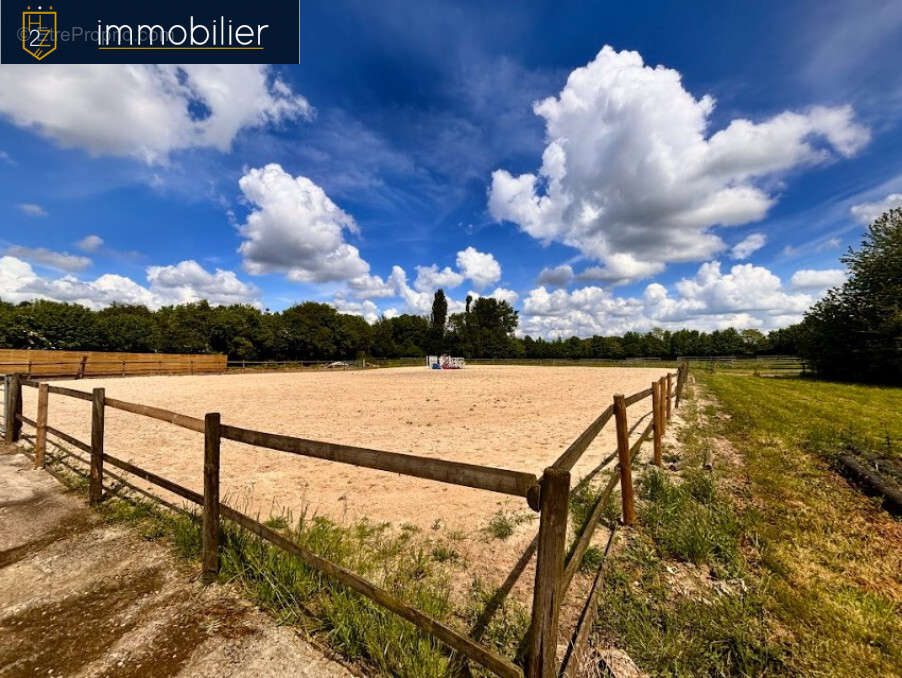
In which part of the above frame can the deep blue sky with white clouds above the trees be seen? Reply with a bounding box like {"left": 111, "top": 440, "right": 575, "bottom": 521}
{"left": 0, "top": 0, "right": 902, "bottom": 338}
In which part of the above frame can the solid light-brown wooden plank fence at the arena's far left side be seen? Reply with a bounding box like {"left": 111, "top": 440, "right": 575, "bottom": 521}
{"left": 0, "top": 348, "right": 226, "bottom": 379}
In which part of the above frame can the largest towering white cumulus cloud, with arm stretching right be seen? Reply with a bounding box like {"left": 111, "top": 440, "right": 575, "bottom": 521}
{"left": 488, "top": 46, "right": 870, "bottom": 281}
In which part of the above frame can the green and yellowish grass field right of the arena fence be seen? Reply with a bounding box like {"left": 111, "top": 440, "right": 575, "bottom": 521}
{"left": 596, "top": 371, "right": 902, "bottom": 678}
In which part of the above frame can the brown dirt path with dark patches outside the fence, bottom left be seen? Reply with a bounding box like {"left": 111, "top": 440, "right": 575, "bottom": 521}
{"left": 0, "top": 446, "right": 352, "bottom": 678}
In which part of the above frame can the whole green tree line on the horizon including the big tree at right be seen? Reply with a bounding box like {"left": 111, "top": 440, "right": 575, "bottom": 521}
{"left": 0, "top": 209, "right": 902, "bottom": 383}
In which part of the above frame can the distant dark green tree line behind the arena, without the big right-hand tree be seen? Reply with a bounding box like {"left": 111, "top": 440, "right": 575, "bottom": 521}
{"left": 0, "top": 290, "right": 797, "bottom": 360}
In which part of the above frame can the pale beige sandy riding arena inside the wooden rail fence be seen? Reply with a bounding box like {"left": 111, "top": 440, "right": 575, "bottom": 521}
{"left": 23, "top": 366, "right": 665, "bottom": 531}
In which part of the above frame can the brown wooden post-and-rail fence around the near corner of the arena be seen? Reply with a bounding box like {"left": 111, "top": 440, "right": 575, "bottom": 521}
{"left": 4, "top": 363, "right": 688, "bottom": 678}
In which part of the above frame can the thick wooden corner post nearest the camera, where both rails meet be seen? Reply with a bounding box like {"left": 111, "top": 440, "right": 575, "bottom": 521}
{"left": 526, "top": 468, "right": 570, "bottom": 678}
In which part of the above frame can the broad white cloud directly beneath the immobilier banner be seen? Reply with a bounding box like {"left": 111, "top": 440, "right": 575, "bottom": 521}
{"left": 0, "top": 64, "right": 313, "bottom": 163}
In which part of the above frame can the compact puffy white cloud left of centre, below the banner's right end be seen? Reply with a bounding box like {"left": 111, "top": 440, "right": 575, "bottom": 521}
{"left": 238, "top": 163, "right": 370, "bottom": 282}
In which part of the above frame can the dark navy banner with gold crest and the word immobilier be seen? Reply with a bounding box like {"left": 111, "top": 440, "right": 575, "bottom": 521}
{"left": 0, "top": 0, "right": 300, "bottom": 64}
